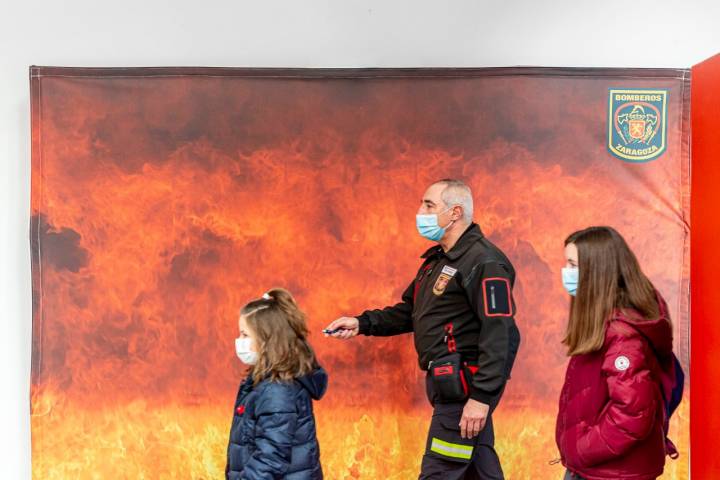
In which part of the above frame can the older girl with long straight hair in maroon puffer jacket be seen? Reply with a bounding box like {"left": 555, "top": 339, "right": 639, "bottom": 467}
{"left": 556, "top": 227, "right": 675, "bottom": 480}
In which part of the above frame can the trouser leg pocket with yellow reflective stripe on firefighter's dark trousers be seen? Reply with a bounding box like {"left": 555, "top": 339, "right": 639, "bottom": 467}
{"left": 425, "top": 404, "right": 475, "bottom": 463}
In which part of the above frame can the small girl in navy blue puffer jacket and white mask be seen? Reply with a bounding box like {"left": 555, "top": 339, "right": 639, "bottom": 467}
{"left": 225, "top": 288, "right": 327, "bottom": 480}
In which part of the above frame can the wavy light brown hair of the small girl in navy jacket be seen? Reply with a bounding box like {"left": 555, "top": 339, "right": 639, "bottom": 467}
{"left": 240, "top": 288, "right": 317, "bottom": 384}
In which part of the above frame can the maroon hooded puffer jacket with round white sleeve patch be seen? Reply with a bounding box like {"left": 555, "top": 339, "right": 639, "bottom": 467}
{"left": 555, "top": 298, "right": 675, "bottom": 480}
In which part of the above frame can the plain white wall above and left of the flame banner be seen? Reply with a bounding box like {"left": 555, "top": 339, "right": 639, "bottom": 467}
{"left": 0, "top": 0, "right": 720, "bottom": 479}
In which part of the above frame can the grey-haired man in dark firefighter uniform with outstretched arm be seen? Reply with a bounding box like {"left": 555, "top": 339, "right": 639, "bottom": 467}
{"left": 324, "top": 179, "right": 520, "bottom": 480}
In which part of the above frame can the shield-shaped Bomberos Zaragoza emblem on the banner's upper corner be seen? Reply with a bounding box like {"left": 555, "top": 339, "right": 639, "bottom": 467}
{"left": 608, "top": 89, "right": 668, "bottom": 162}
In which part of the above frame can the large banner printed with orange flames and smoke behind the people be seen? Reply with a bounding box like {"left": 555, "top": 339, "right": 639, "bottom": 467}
{"left": 31, "top": 67, "right": 690, "bottom": 480}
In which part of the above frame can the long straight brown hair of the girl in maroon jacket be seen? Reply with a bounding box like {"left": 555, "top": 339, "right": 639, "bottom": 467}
{"left": 562, "top": 227, "right": 660, "bottom": 355}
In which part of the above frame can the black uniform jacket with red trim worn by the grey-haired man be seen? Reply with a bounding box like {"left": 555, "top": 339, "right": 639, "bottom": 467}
{"left": 357, "top": 223, "right": 520, "bottom": 407}
